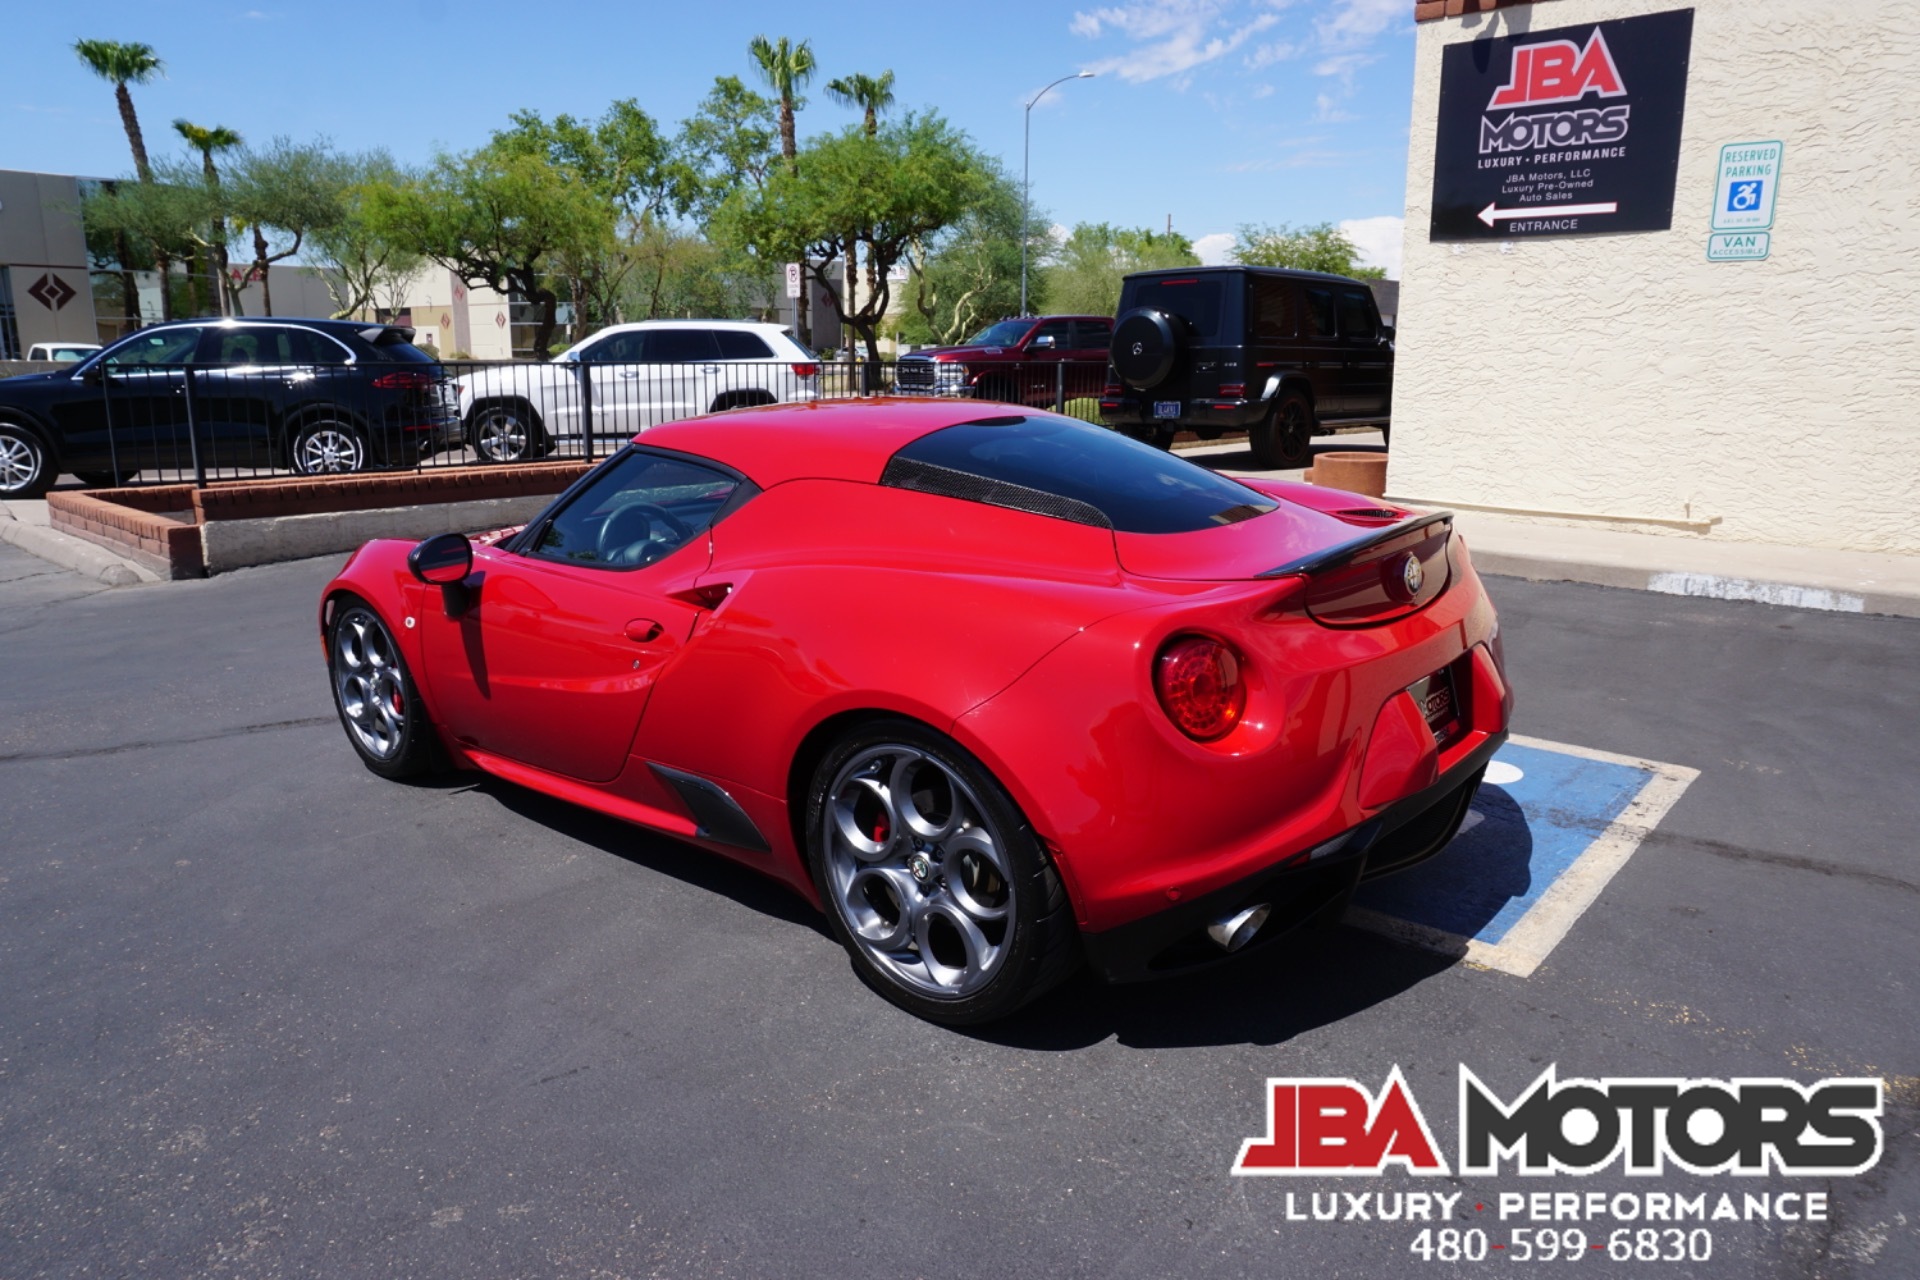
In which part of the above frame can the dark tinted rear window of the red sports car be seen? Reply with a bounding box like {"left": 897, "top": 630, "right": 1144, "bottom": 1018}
{"left": 879, "top": 415, "right": 1277, "bottom": 533}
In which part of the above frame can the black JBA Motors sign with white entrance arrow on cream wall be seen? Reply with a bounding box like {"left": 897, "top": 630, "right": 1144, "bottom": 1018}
{"left": 1428, "top": 10, "right": 1693, "bottom": 240}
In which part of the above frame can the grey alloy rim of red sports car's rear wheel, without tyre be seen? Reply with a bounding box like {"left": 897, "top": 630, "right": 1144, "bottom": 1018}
{"left": 820, "top": 743, "right": 1016, "bottom": 1000}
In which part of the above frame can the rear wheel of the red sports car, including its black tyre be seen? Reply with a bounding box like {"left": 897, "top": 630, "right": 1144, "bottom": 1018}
{"left": 806, "top": 718, "right": 1079, "bottom": 1025}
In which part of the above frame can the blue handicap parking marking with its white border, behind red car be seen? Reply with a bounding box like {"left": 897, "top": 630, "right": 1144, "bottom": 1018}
{"left": 1346, "top": 735, "right": 1699, "bottom": 977}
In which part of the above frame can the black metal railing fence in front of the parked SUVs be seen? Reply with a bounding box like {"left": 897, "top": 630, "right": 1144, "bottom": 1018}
{"left": 48, "top": 355, "right": 1108, "bottom": 486}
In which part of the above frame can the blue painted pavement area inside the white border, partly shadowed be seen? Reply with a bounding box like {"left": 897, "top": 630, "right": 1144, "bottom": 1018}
{"left": 1354, "top": 743, "right": 1657, "bottom": 944}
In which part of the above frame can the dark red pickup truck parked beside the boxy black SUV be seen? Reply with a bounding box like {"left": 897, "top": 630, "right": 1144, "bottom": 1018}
{"left": 893, "top": 315, "right": 1114, "bottom": 405}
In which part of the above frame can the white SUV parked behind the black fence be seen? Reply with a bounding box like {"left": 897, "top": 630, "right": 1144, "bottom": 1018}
{"left": 449, "top": 320, "right": 820, "bottom": 462}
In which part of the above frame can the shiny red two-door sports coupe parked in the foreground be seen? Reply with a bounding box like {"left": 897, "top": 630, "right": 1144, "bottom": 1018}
{"left": 321, "top": 399, "right": 1511, "bottom": 1023}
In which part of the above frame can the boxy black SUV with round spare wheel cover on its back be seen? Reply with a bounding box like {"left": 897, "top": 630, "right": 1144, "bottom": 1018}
{"left": 1100, "top": 267, "right": 1394, "bottom": 468}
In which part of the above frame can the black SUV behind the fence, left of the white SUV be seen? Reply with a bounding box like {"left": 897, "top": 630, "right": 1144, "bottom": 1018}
{"left": 0, "top": 319, "right": 461, "bottom": 497}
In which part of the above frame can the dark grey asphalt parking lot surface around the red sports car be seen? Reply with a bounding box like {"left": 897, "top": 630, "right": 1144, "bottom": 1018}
{"left": 0, "top": 547, "right": 1920, "bottom": 1280}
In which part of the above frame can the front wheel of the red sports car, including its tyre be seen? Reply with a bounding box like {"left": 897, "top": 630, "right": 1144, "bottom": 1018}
{"left": 326, "top": 601, "right": 434, "bottom": 779}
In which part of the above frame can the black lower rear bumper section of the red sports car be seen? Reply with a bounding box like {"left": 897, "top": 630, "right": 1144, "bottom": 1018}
{"left": 1081, "top": 731, "right": 1507, "bottom": 983}
